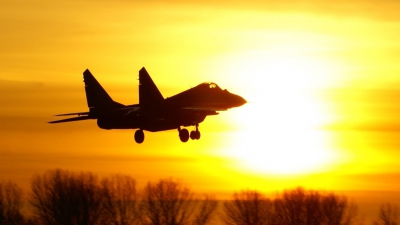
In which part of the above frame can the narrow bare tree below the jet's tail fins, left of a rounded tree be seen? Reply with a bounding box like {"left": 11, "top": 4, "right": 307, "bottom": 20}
{"left": 101, "top": 175, "right": 139, "bottom": 225}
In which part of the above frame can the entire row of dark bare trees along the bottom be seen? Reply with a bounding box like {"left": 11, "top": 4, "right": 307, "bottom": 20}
{"left": 0, "top": 169, "right": 399, "bottom": 225}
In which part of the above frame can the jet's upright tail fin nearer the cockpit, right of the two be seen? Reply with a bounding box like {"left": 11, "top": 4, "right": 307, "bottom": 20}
{"left": 139, "top": 67, "right": 164, "bottom": 111}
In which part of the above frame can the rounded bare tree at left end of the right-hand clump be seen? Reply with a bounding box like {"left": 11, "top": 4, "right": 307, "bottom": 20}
{"left": 222, "top": 190, "right": 273, "bottom": 225}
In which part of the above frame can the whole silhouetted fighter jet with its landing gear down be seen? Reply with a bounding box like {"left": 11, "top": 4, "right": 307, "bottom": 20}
{"left": 49, "top": 67, "right": 246, "bottom": 144}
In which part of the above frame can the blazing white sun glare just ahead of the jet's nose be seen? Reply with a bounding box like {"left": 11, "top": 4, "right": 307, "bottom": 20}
{"left": 211, "top": 41, "right": 339, "bottom": 175}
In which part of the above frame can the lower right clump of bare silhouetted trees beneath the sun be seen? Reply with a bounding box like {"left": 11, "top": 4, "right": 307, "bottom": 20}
{"left": 223, "top": 188, "right": 360, "bottom": 225}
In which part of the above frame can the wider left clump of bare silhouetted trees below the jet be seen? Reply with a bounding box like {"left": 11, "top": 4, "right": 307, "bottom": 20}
{"left": 31, "top": 169, "right": 217, "bottom": 225}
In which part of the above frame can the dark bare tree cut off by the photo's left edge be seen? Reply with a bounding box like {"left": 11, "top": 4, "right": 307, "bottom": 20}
{"left": 0, "top": 182, "right": 24, "bottom": 225}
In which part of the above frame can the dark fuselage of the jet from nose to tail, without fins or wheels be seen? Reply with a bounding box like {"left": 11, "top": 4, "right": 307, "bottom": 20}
{"left": 97, "top": 83, "right": 246, "bottom": 132}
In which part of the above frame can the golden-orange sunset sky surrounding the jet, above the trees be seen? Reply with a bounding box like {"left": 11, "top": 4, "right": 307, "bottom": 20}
{"left": 0, "top": 0, "right": 400, "bottom": 219}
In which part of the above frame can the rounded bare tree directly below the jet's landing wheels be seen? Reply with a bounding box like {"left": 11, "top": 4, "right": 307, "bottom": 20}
{"left": 141, "top": 179, "right": 196, "bottom": 225}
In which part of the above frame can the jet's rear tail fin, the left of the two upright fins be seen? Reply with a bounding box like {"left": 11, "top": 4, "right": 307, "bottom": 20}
{"left": 83, "top": 69, "right": 123, "bottom": 116}
